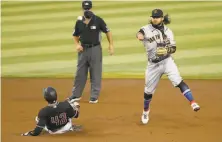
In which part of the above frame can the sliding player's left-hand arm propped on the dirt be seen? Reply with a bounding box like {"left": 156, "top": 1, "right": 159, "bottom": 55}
{"left": 22, "top": 110, "right": 46, "bottom": 136}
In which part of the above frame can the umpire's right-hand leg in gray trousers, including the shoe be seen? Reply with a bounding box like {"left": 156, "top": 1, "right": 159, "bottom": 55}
{"left": 89, "top": 45, "right": 102, "bottom": 103}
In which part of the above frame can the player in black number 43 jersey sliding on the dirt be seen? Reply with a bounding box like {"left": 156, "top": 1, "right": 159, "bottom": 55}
{"left": 22, "top": 87, "right": 81, "bottom": 136}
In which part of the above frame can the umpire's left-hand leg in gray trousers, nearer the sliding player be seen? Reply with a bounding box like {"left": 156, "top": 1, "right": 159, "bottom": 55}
{"left": 69, "top": 49, "right": 89, "bottom": 100}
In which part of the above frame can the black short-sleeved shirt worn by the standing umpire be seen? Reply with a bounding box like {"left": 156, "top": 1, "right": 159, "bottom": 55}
{"left": 73, "top": 15, "right": 109, "bottom": 44}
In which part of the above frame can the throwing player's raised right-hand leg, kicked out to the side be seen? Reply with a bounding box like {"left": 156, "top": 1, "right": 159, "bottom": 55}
{"left": 164, "top": 58, "right": 200, "bottom": 111}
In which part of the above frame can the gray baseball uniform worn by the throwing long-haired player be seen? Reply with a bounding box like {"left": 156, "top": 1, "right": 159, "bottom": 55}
{"left": 141, "top": 24, "right": 182, "bottom": 94}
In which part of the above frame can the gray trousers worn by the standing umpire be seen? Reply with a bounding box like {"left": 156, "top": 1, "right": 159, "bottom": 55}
{"left": 70, "top": 45, "right": 102, "bottom": 99}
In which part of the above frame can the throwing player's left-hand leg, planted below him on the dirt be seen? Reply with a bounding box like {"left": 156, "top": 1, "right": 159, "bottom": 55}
{"left": 141, "top": 64, "right": 163, "bottom": 124}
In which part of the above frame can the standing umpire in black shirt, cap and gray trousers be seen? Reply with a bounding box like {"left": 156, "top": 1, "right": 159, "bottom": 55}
{"left": 69, "top": 1, "right": 114, "bottom": 103}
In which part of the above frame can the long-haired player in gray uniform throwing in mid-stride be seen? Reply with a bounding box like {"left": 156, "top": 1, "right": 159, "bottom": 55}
{"left": 137, "top": 9, "right": 200, "bottom": 124}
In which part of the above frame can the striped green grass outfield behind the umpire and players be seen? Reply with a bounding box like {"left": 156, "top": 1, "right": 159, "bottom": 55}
{"left": 1, "top": 1, "right": 222, "bottom": 79}
